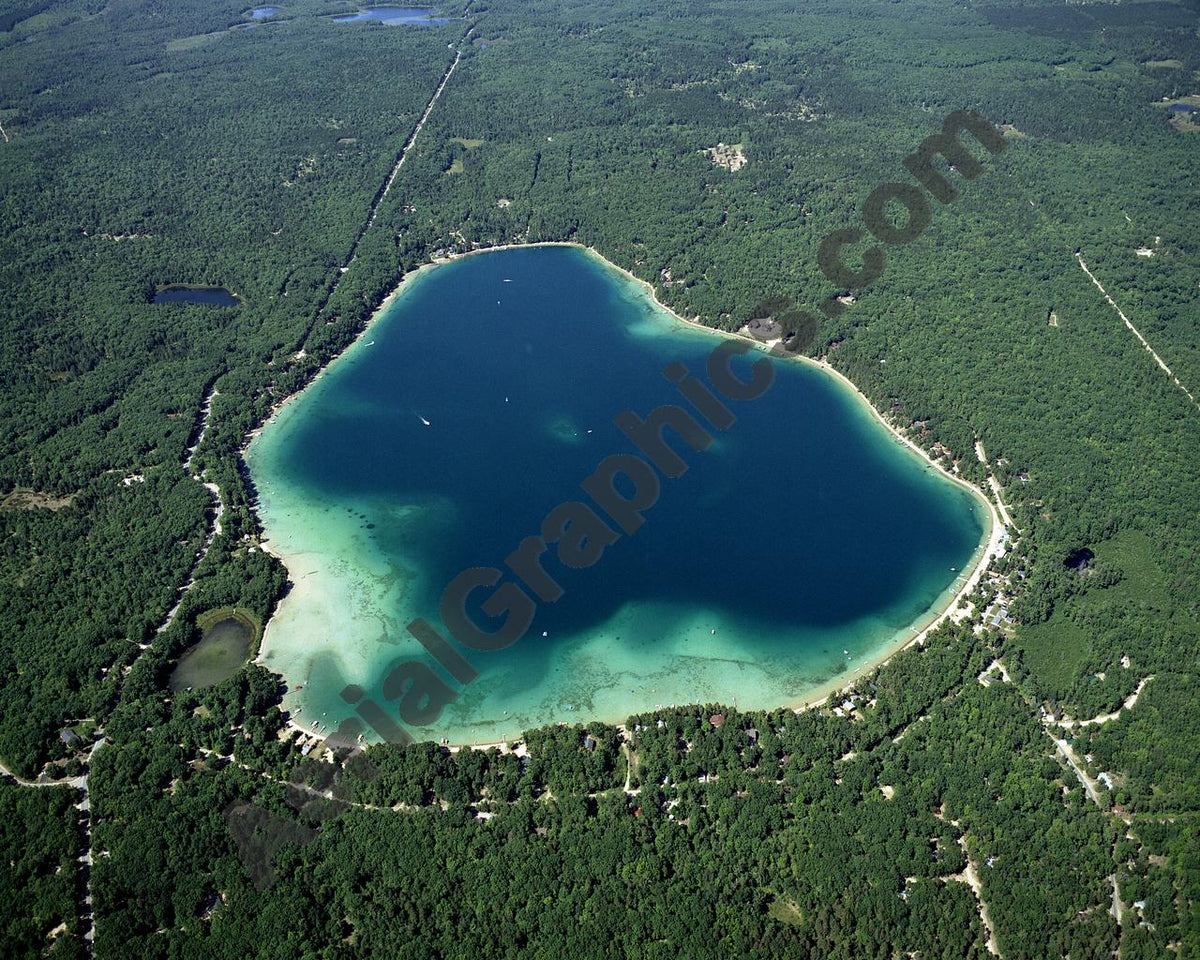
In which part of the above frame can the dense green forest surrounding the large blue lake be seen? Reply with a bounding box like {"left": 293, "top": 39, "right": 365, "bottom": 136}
{"left": 0, "top": 0, "right": 1200, "bottom": 960}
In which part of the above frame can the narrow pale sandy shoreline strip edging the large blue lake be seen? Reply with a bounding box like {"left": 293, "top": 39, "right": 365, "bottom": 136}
{"left": 248, "top": 240, "right": 1006, "bottom": 751}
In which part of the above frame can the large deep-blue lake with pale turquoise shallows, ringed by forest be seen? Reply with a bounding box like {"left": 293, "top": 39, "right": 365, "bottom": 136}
{"left": 247, "top": 247, "right": 988, "bottom": 742}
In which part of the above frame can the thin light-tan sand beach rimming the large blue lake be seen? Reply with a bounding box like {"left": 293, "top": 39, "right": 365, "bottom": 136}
{"left": 248, "top": 242, "right": 1004, "bottom": 749}
